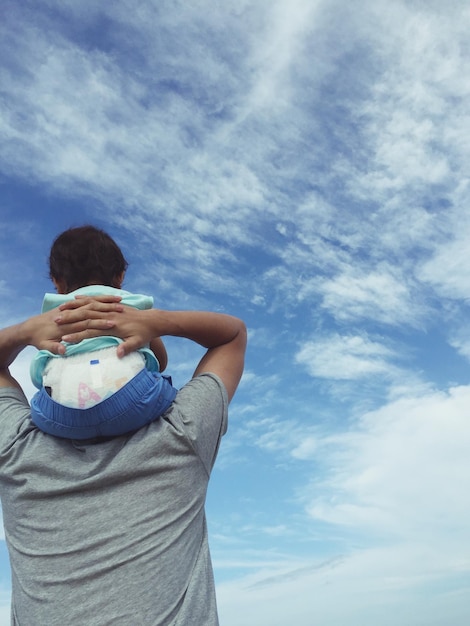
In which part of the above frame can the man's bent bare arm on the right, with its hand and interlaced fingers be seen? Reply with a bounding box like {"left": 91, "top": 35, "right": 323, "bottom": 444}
{"left": 60, "top": 301, "right": 246, "bottom": 400}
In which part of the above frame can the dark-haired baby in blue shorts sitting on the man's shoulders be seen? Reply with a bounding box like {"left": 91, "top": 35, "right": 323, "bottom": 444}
{"left": 31, "top": 226, "right": 177, "bottom": 439}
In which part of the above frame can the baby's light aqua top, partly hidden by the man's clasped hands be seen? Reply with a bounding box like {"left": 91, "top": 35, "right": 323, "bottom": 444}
{"left": 30, "top": 285, "right": 160, "bottom": 389}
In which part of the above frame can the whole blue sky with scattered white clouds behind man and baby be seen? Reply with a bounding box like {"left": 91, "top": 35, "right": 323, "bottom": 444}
{"left": 0, "top": 0, "right": 470, "bottom": 626}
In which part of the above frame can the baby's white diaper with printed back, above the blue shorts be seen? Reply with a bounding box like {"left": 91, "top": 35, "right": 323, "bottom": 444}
{"left": 43, "top": 346, "right": 145, "bottom": 409}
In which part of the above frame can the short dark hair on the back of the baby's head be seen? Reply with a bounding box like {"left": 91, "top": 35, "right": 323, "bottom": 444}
{"left": 49, "top": 225, "right": 128, "bottom": 293}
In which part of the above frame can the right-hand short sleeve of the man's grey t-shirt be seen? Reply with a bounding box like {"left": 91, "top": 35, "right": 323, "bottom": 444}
{"left": 168, "top": 373, "right": 228, "bottom": 474}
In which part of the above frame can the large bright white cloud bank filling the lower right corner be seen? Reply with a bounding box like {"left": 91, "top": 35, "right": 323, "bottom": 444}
{"left": 218, "top": 386, "right": 470, "bottom": 626}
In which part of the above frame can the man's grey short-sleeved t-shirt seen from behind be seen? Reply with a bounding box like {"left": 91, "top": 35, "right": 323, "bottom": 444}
{"left": 0, "top": 374, "right": 228, "bottom": 626}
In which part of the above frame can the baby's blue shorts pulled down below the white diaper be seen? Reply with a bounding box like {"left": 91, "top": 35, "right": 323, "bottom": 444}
{"left": 31, "top": 368, "right": 177, "bottom": 439}
